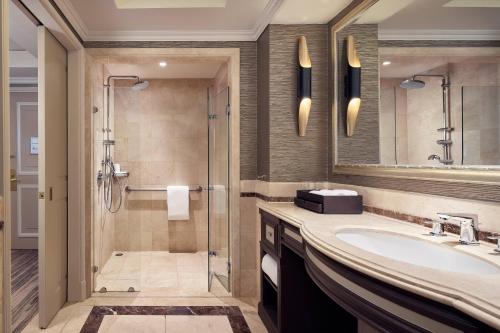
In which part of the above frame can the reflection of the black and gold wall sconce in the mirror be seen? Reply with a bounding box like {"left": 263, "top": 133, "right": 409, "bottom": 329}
{"left": 345, "top": 36, "right": 361, "bottom": 136}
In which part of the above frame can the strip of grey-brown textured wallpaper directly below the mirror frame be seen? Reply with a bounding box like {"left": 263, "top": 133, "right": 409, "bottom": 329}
{"left": 331, "top": 174, "right": 500, "bottom": 202}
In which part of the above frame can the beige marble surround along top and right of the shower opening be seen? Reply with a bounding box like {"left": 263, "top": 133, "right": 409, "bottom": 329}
{"left": 86, "top": 48, "right": 240, "bottom": 297}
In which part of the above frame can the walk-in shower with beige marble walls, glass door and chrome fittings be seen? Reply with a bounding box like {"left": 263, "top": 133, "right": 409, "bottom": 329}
{"left": 92, "top": 64, "right": 231, "bottom": 296}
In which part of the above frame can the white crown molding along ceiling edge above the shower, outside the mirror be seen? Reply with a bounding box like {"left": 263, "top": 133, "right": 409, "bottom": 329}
{"left": 54, "top": 0, "right": 283, "bottom": 42}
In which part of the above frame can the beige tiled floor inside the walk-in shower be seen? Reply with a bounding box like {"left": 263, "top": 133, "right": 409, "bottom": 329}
{"left": 95, "top": 251, "right": 229, "bottom": 297}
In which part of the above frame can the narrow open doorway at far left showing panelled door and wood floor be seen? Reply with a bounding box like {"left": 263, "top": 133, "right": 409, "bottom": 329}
{"left": 9, "top": 3, "right": 38, "bottom": 333}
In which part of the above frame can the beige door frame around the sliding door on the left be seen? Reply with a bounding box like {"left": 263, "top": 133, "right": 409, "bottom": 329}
{"left": 0, "top": 0, "right": 87, "bottom": 332}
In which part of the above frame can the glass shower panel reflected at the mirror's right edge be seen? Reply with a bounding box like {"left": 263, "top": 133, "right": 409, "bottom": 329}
{"left": 460, "top": 86, "right": 500, "bottom": 165}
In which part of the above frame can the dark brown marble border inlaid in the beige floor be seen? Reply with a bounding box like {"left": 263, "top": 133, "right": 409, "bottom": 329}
{"left": 80, "top": 306, "right": 250, "bottom": 333}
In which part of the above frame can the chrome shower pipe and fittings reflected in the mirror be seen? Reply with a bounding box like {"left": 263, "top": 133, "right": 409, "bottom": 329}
{"left": 412, "top": 74, "right": 454, "bottom": 165}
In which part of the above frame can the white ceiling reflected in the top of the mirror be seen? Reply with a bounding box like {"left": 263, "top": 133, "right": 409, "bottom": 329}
{"left": 356, "top": 0, "right": 500, "bottom": 40}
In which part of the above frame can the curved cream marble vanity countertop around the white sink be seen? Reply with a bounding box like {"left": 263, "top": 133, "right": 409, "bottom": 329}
{"left": 257, "top": 200, "right": 500, "bottom": 330}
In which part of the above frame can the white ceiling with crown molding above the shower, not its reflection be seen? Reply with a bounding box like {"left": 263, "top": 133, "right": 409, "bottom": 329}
{"left": 55, "top": 0, "right": 350, "bottom": 41}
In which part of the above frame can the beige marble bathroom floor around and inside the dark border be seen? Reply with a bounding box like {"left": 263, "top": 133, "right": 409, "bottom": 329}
{"left": 23, "top": 293, "right": 267, "bottom": 333}
